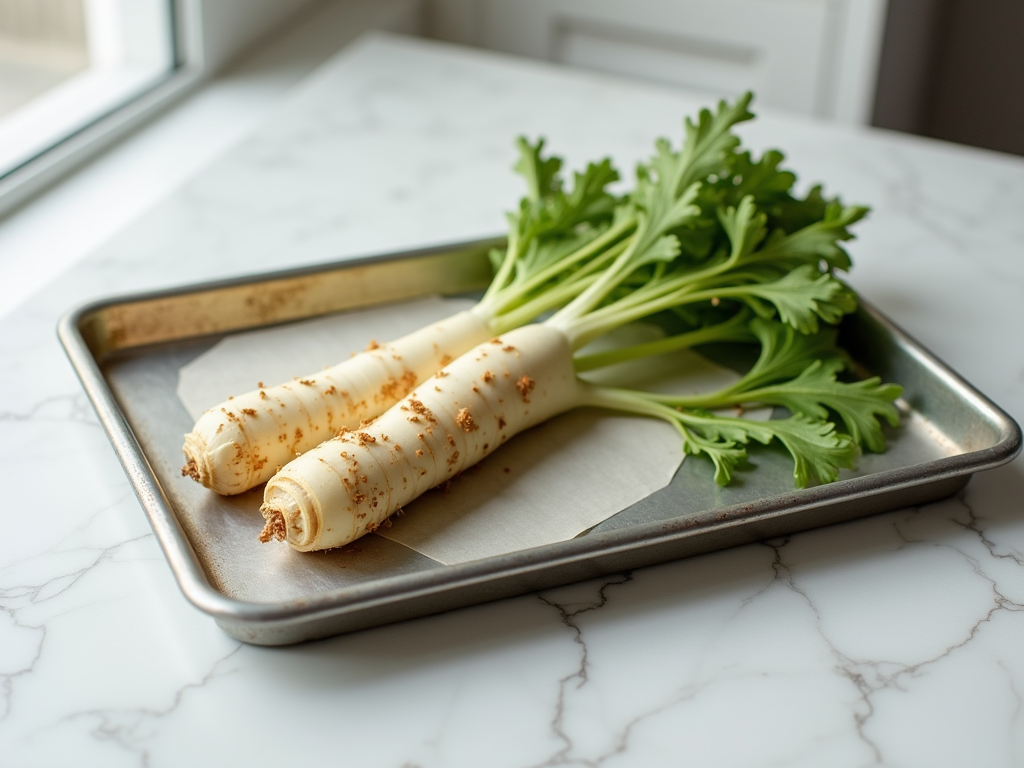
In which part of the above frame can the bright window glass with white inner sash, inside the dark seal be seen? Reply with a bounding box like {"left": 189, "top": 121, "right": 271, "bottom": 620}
{"left": 0, "top": 0, "right": 175, "bottom": 178}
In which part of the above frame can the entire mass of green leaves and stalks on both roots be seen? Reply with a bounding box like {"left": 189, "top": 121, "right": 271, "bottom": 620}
{"left": 468, "top": 94, "right": 901, "bottom": 486}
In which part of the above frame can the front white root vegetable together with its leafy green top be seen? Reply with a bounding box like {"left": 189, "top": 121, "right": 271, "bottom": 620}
{"left": 251, "top": 94, "right": 899, "bottom": 551}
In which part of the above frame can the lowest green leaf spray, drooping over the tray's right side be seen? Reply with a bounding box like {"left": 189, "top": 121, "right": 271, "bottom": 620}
{"left": 581, "top": 318, "right": 902, "bottom": 487}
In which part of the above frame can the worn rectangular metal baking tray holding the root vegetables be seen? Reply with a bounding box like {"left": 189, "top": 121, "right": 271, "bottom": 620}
{"left": 59, "top": 241, "right": 1021, "bottom": 645}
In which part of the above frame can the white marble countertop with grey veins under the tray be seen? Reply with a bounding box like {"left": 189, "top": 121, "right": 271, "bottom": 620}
{"left": 0, "top": 27, "right": 1024, "bottom": 768}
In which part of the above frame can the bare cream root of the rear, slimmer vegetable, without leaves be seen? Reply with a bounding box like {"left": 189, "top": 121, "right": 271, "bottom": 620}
{"left": 181, "top": 309, "right": 494, "bottom": 495}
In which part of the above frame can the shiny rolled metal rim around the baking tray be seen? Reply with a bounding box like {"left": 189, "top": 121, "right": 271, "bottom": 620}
{"left": 57, "top": 238, "right": 1022, "bottom": 626}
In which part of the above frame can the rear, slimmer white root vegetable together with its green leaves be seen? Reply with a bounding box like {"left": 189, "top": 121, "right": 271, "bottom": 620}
{"left": 181, "top": 139, "right": 618, "bottom": 494}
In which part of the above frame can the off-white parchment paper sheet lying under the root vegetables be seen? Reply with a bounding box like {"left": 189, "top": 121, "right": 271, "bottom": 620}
{"left": 177, "top": 297, "right": 770, "bottom": 564}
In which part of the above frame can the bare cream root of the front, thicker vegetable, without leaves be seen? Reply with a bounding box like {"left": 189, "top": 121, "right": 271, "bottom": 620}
{"left": 260, "top": 325, "right": 583, "bottom": 551}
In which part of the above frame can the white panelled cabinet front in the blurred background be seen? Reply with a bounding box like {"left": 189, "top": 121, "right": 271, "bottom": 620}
{"left": 426, "top": 0, "right": 888, "bottom": 124}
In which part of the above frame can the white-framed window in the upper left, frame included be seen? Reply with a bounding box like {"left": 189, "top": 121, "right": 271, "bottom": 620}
{"left": 0, "top": 0, "right": 348, "bottom": 215}
